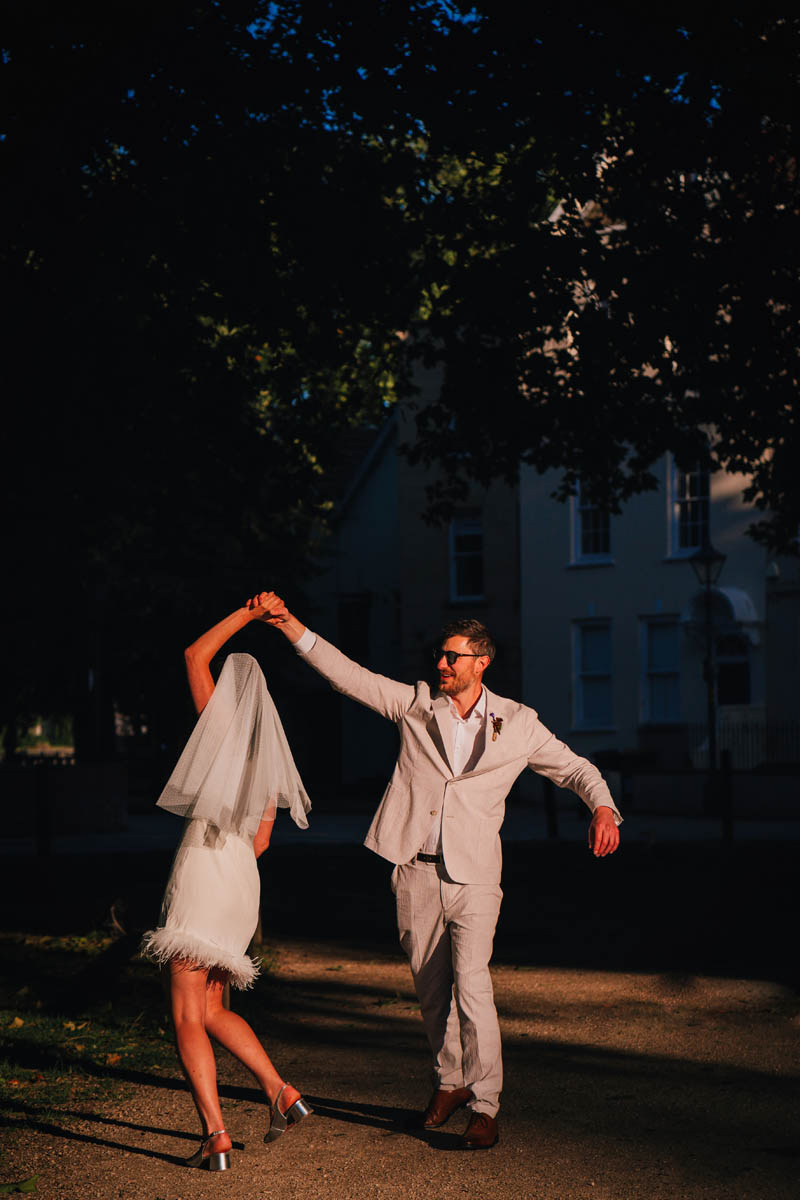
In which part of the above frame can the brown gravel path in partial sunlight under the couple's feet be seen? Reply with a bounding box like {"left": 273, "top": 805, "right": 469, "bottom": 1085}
{"left": 2, "top": 941, "right": 800, "bottom": 1200}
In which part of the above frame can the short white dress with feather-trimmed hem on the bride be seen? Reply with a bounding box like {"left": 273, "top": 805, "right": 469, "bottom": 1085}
{"left": 142, "top": 820, "right": 260, "bottom": 989}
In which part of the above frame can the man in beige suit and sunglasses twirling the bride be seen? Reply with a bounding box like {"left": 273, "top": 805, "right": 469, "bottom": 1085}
{"left": 252, "top": 593, "right": 621, "bottom": 1150}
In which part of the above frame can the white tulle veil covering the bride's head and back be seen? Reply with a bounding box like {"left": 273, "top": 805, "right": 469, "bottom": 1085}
{"left": 158, "top": 654, "right": 311, "bottom": 840}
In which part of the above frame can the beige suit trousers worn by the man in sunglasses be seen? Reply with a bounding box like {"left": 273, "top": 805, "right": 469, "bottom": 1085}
{"left": 392, "top": 862, "right": 503, "bottom": 1116}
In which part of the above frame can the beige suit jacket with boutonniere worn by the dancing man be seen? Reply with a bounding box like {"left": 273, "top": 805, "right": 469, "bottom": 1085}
{"left": 303, "top": 636, "right": 621, "bottom": 883}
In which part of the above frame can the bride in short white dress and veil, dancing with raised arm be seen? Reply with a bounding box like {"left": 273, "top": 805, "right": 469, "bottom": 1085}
{"left": 143, "top": 592, "right": 312, "bottom": 1170}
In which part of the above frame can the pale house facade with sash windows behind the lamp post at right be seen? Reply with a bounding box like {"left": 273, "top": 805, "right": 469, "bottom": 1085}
{"left": 519, "top": 456, "right": 796, "bottom": 769}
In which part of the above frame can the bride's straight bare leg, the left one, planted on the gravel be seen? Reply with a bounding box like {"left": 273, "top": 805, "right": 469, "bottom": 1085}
{"left": 169, "top": 959, "right": 231, "bottom": 1153}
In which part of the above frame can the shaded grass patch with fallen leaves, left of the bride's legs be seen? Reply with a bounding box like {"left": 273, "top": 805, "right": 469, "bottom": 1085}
{"left": 0, "top": 916, "right": 276, "bottom": 1194}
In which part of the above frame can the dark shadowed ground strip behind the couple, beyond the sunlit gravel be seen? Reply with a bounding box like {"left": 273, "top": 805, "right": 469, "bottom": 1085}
{"left": 0, "top": 842, "right": 798, "bottom": 989}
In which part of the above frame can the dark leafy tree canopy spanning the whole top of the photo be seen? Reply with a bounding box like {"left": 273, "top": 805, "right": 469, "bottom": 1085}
{"left": 0, "top": 0, "right": 800, "bottom": 748}
